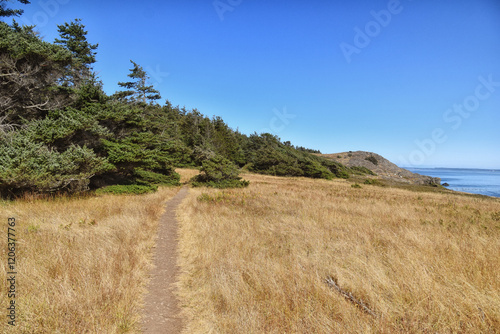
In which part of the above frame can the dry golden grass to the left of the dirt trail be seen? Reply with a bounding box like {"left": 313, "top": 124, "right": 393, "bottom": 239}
{"left": 0, "top": 188, "right": 178, "bottom": 333}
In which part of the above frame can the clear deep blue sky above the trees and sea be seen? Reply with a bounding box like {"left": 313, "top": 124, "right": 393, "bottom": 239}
{"left": 10, "top": 0, "right": 500, "bottom": 169}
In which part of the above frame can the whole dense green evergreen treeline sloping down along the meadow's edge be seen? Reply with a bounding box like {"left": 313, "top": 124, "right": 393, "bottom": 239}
{"left": 0, "top": 1, "right": 372, "bottom": 196}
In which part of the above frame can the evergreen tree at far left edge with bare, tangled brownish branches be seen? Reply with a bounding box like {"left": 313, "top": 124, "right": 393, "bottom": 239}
{"left": 0, "top": 22, "right": 72, "bottom": 122}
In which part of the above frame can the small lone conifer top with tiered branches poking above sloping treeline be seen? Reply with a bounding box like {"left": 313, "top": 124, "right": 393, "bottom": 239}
{"left": 114, "top": 60, "right": 161, "bottom": 103}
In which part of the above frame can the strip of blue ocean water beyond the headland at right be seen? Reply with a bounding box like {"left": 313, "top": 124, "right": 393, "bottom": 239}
{"left": 406, "top": 168, "right": 500, "bottom": 197}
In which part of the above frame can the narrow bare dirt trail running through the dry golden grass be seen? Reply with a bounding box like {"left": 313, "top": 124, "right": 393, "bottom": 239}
{"left": 142, "top": 186, "right": 188, "bottom": 334}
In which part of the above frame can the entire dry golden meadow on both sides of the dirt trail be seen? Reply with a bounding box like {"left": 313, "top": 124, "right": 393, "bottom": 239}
{"left": 0, "top": 169, "right": 500, "bottom": 333}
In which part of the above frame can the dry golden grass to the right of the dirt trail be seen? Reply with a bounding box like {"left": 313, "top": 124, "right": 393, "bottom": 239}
{"left": 178, "top": 175, "right": 500, "bottom": 333}
